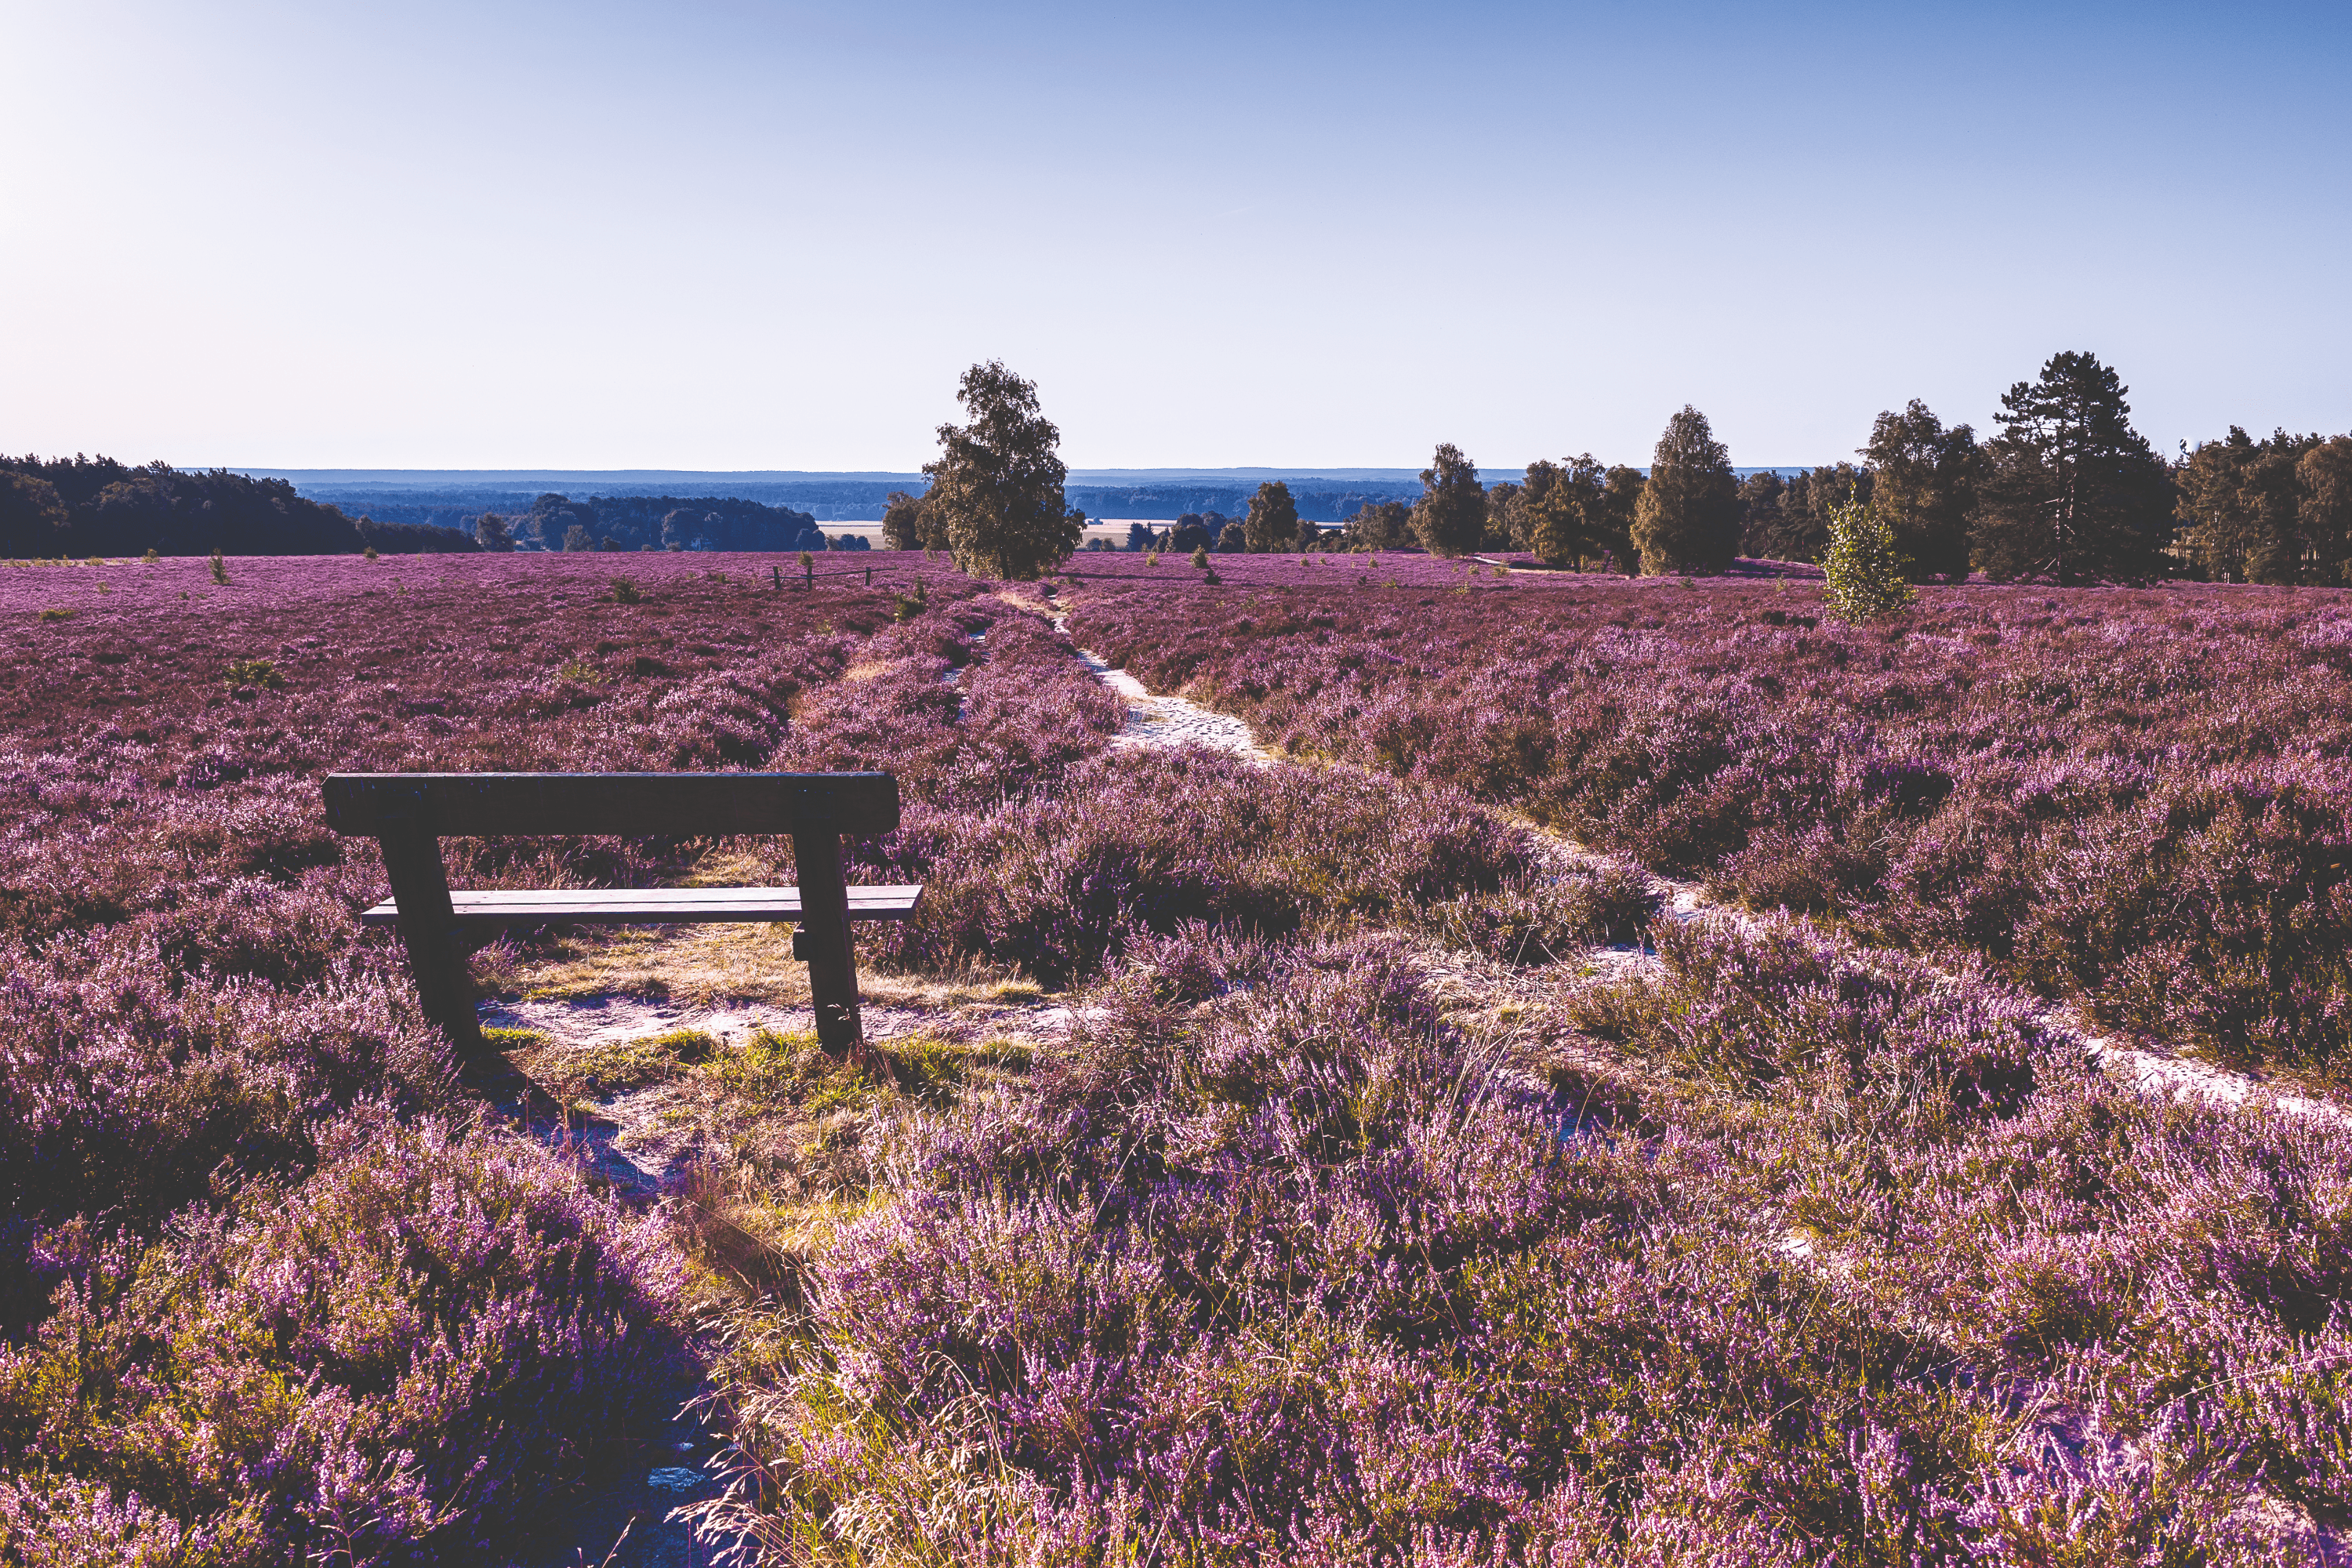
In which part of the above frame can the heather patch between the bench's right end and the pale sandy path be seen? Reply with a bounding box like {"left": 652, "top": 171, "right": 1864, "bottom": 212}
{"left": 767, "top": 609, "right": 1653, "bottom": 985}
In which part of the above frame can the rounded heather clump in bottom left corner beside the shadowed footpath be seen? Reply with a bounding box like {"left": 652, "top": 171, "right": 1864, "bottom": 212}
{"left": 0, "top": 1107, "right": 680, "bottom": 1563}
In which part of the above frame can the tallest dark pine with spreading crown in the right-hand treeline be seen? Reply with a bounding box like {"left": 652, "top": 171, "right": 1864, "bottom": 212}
{"left": 1976, "top": 353, "right": 2173, "bottom": 583}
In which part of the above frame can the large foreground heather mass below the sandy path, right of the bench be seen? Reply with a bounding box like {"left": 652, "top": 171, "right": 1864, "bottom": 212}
{"left": 687, "top": 926, "right": 2345, "bottom": 1566}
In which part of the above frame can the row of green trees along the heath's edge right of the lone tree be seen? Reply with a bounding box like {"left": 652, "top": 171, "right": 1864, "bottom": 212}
{"left": 1063, "top": 353, "right": 2352, "bottom": 588}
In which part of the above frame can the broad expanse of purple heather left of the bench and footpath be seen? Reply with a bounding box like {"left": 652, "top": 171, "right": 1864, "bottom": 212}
{"left": 0, "top": 557, "right": 974, "bottom": 1563}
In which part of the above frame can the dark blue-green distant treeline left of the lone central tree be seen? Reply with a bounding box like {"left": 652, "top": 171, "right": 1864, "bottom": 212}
{"left": 0, "top": 456, "right": 863, "bottom": 560}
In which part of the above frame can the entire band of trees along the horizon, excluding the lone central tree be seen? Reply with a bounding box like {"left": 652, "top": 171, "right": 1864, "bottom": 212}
{"left": 13, "top": 353, "right": 2352, "bottom": 586}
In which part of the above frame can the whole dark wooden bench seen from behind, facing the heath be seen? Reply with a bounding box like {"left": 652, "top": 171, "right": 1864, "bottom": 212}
{"left": 325, "top": 774, "right": 922, "bottom": 1055}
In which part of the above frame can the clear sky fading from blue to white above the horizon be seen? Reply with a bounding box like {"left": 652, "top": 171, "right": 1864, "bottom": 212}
{"left": 0, "top": 0, "right": 2352, "bottom": 475}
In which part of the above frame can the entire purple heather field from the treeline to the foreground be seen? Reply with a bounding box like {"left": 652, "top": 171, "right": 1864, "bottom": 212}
{"left": 0, "top": 553, "right": 2352, "bottom": 1568}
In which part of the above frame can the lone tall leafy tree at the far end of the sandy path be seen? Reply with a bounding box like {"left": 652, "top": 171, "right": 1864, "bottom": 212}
{"left": 922, "top": 360, "right": 1087, "bottom": 579}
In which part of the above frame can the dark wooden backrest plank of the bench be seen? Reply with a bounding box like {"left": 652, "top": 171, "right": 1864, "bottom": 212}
{"left": 327, "top": 774, "right": 898, "bottom": 837}
